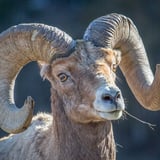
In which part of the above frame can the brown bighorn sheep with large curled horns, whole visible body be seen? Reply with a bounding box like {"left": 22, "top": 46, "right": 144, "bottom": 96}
{"left": 0, "top": 14, "right": 160, "bottom": 160}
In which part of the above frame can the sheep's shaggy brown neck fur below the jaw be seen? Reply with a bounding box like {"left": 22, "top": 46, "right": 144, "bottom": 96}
{"left": 49, "top": 89, "right": 115, "bottom": 160}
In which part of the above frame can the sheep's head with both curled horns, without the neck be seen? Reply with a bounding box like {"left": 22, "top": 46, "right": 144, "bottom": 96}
{"left": 0, "top": 14, "right": 160, "bottom": 133}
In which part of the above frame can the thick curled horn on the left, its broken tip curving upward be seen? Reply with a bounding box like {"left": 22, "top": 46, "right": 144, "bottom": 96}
{"left": 0, "top": 24, "right": 74, "bottom": 133}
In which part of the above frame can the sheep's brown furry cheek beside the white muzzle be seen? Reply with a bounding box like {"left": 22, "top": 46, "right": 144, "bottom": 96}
{"left": 64, "top": 86, "right": 97, "bottom": 123}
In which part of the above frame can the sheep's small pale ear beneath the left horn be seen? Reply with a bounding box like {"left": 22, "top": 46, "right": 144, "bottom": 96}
{"left": 38, "top": 61, "right": 51, "bottom": 80}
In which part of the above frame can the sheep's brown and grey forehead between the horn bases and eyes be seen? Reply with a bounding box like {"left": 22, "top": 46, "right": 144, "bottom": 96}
{"left": 52, "top": 41, "right": 113, "bottom": 70}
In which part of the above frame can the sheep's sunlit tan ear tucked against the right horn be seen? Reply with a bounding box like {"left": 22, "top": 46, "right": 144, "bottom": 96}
{"left": 101, "top": 48, "right": 121, "bottom": 66}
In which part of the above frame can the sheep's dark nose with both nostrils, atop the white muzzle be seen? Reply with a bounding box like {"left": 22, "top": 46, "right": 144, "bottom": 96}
{"left": 101, "top": 89, "right": 122, "bottom": 102}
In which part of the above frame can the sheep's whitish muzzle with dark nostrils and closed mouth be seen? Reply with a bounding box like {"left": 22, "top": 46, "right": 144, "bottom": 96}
{"left": 94, "top": 85, "right": 125, "bottom": 120}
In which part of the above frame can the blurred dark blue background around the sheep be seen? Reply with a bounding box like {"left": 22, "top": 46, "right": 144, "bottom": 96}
{"left": 0, "top": 0, "right": 160, "bottom": 160}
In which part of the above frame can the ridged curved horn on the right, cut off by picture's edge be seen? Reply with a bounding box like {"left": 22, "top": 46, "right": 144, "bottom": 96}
{"left": 84, "top": 14, "right": 160, "bottom": 110}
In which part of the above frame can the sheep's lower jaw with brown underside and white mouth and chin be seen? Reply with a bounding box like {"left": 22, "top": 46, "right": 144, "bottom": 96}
{"left": 62, "top": 94, "right": 125, "bottom": 124}
